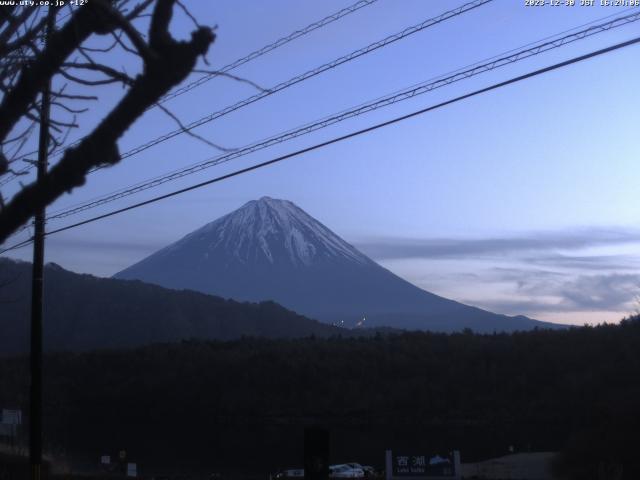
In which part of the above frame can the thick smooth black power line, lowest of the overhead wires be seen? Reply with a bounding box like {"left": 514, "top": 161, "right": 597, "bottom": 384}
{"left": 0, "top": 33, "right": 640, "bottom": 254}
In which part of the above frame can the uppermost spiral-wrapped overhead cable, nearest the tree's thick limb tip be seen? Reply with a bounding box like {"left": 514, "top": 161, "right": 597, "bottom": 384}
{"left": 0, "top": 0, "right": 378, "bottom": 186}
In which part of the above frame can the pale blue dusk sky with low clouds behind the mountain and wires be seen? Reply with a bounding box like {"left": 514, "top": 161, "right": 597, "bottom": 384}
{"left": 1, "top": 0, "right": 640, "bottom": 324}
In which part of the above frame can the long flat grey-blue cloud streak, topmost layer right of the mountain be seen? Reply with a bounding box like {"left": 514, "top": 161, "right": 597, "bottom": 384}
{"left": 357, "top": 228, "right": 640, "bottom": 264}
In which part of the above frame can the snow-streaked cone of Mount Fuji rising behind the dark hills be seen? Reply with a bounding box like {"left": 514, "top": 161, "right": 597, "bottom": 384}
{"left": 115, "top": 197, "right": 556, "bottom": 332}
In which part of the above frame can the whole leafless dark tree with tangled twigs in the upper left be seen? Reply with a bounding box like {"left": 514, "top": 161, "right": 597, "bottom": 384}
{"left": 0, "top": 0, "right": 215, "bottom": 244}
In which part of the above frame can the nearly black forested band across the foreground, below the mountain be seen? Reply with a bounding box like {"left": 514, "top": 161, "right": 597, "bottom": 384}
{"left": 0, "top": 319, "right": 640, "bottom": 480}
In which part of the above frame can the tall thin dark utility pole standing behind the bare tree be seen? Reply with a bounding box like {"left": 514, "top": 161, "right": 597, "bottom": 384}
{"left": 29, "top": 7, "right": 56, "bottom": 480}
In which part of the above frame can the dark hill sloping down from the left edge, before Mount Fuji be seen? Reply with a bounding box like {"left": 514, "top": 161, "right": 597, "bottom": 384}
{"left": 0, "top": 258, "right": 338, "bottom": 355}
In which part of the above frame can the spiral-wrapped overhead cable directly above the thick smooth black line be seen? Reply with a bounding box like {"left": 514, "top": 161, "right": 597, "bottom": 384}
{"left": 38, "top": 12, "right": 640, "bottom": 225}
